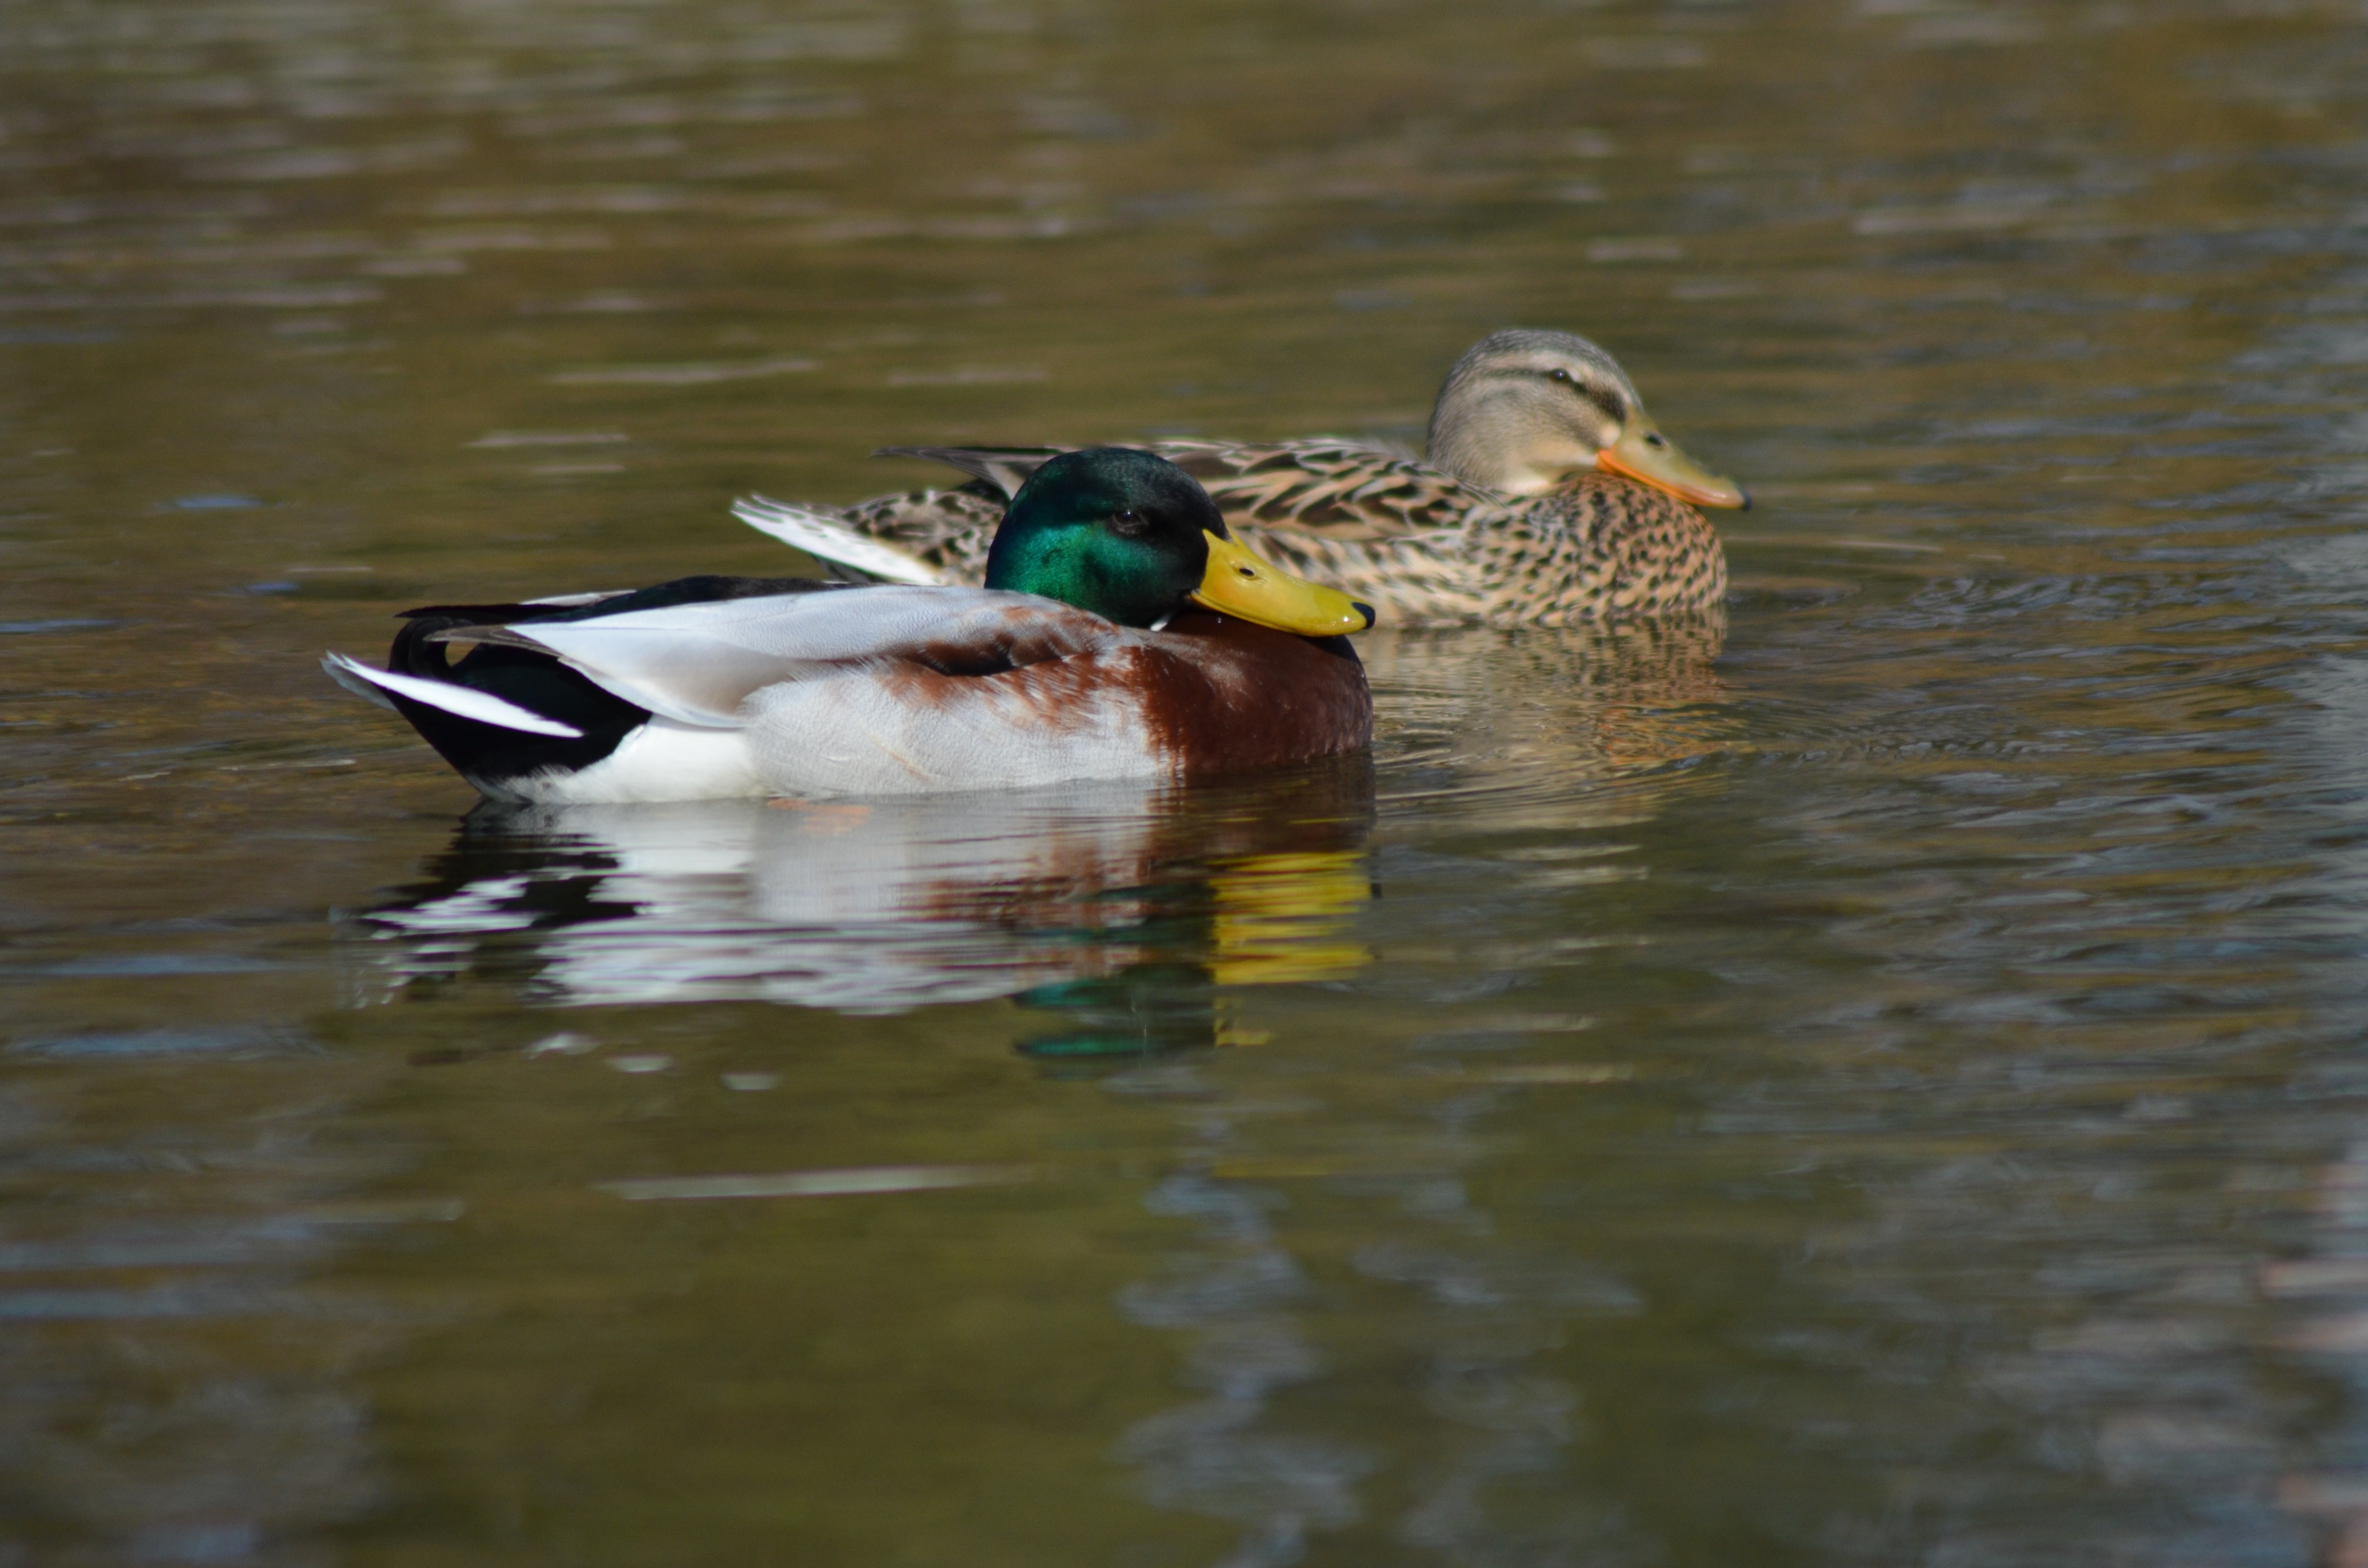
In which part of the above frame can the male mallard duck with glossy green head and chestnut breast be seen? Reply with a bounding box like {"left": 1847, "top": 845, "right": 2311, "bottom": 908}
{"left": 324, "top": 448, "right": 1373, "bottom": 805}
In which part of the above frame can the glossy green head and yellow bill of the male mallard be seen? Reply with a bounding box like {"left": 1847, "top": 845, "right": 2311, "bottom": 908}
{"left": 987, "top": 445, "right": 1373, "bottom": 637}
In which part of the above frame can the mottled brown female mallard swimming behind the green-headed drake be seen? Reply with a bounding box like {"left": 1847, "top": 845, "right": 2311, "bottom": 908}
{"left": 734, "top": 331, "right": 1750, "bottom": 625}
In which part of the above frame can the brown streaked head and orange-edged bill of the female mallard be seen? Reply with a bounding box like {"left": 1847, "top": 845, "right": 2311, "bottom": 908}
{"left": 1431, "top": 327, "right": 1752, "bottom": 507}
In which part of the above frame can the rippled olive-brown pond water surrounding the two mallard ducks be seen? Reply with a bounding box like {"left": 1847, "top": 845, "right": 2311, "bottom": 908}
{"left": 0, "top": 0, "right": 2368, "bottom": 1568}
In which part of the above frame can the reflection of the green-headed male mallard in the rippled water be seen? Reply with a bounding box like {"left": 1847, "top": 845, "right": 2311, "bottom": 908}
{"left": 358, "top": 758, "right": 1373, "bottom": 1056}
